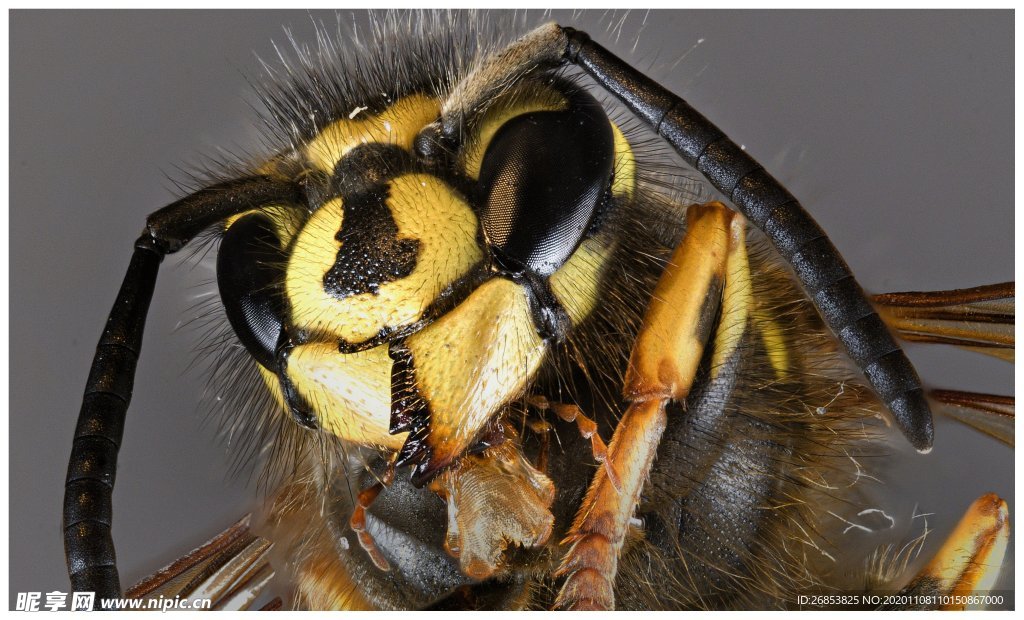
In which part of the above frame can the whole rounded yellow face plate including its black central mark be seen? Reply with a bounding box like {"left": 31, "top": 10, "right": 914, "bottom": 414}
{"left": 287, "top": 173, "right": 483, "bottom": 348}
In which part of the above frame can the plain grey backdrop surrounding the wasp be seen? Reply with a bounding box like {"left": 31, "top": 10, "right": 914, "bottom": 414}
{"left": 10, "top": 11, "right": 1014, "bottom": 601}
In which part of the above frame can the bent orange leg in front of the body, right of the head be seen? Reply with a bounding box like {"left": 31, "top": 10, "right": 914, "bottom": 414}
{"left": 555, "top": 203, "right": 749, "bottom": 610}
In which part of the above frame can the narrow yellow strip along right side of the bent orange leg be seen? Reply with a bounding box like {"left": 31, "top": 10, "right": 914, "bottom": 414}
{"left": 711, "top": 216, "right": 754, "bottom": 378}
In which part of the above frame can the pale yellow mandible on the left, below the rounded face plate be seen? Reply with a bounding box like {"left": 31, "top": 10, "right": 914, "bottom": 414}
{"left": 278, "top": 342, "right": 406, "bottom": 450}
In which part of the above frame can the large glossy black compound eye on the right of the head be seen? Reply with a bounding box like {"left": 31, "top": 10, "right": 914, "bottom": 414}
{"left": 479, "top": 87, "right": 614, "bottom": 276}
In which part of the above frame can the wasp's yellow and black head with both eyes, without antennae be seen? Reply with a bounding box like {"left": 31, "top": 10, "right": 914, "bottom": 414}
{"left": 218, "top": 76, "right": 632, "bottom": 484}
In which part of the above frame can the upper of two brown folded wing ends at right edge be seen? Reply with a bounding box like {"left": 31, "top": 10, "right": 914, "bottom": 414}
{"left": 871, "top": 282, "right": 1015, "bottom": 362}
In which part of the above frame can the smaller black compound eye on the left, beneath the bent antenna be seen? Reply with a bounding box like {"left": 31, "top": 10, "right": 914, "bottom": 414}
{"left": 217, "top": 213, "right": 286, "bottom": 371}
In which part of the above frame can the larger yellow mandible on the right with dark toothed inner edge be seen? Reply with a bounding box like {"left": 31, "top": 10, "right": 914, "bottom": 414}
{"left": 407, "top": 279, "right": 547, "bottom": 461}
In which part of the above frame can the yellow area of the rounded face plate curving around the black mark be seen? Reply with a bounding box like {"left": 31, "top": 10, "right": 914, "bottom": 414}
{"left": 286, "top": 174, "right": 483, "bottom": 343}
